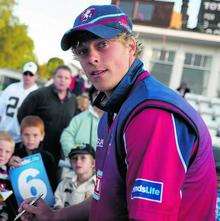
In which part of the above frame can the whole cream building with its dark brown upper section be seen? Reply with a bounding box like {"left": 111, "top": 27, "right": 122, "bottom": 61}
{"left": 112, "top": 0, "right": 220, "bottom": 97}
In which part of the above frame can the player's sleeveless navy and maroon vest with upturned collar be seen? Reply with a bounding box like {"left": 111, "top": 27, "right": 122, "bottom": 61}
{"left": 90, "top": 59, "right": 216, "bottom": 221}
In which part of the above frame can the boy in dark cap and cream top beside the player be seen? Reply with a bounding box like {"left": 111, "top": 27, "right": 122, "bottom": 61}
{"left": 54, "top": 144, "right": 95, "bottom": 209}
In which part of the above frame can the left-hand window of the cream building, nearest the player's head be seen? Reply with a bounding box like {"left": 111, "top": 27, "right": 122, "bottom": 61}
{"left": 151, "top": 49, "right": 175, "bottom": 85}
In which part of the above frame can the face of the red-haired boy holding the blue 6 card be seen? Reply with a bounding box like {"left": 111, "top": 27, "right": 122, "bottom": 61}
{"left": 21, "top": 127, "right": 44, "bottom": 150}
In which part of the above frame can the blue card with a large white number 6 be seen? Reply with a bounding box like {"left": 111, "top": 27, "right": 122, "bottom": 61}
{"left": 9, "top": 153, "right": 54, "bottom": 206}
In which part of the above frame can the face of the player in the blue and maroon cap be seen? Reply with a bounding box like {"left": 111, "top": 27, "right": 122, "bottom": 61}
{"left": 74, "top": 38, "right": 136, "bottom": 92}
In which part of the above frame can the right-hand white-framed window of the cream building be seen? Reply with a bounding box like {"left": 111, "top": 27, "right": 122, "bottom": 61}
{"left": 182, "top": 53, "right": 212, "bottom": 95}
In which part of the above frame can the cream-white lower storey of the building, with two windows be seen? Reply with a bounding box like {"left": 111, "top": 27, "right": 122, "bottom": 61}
{"left": 137, "top": 25, "right": 220, "bottom": 97}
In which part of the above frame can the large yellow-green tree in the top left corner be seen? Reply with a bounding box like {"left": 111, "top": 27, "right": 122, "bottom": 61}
{"left": 0, "top": 0, "right": 36, "bottom": 70}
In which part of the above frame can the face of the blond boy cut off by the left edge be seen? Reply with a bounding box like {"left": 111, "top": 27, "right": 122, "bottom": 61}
{"left": 0, "top": 140, "right": 14, "bottom": 165}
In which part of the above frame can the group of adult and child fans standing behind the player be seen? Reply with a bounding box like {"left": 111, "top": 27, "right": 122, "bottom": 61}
{"left": 0, "top": 59, "right": 103, "bottom": 220}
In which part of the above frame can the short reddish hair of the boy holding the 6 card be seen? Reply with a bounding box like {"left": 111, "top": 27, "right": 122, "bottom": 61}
{"left": 21, "top": 115, "right": 45, "bottom": 134}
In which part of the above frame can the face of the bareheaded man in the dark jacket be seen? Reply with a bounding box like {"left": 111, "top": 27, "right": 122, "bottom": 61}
{"left": 53, "top": 68, "right": 71, "bottom": 92}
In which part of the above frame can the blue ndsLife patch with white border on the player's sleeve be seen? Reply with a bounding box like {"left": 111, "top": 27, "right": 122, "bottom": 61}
{"left": 131, "top": 179, "right": 163, "bottom": 203}
